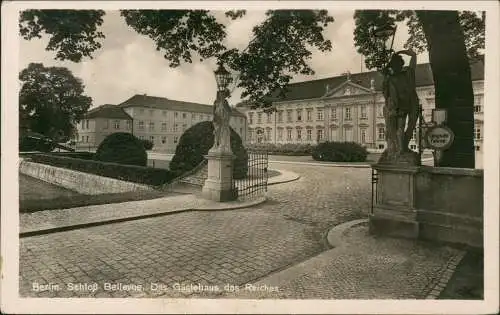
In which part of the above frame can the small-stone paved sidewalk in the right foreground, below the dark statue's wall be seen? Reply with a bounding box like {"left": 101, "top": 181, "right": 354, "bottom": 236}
{"left": 223, "top": 220, "right": 465, "bottom": 299}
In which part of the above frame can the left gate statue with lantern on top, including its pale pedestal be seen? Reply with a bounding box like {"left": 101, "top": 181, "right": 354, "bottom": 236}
{"left": 202, "top": 63, "right": 237, "bottom": 202}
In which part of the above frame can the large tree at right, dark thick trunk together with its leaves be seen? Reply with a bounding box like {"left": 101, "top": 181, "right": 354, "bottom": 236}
{"left": 354, "top": 10, "right": 485, "bottom": 168}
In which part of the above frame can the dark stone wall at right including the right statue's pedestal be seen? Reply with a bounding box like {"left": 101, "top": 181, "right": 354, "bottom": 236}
{"left": 370, "top": 164, "right": 484, "bottom": 248}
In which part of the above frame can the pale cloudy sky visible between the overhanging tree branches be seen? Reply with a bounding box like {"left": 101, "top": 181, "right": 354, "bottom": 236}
{"left": 19, "top": 10, "right": 428, "bottom": 107}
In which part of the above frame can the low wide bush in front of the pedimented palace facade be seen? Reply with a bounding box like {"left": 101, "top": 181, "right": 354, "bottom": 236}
{"left": 312, "top": 142, "right": 368, "bottom": 162}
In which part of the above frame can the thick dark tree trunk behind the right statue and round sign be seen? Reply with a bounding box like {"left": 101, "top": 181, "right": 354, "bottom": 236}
{"left": 416, "top": 11, "right": 475, "bottom": 168}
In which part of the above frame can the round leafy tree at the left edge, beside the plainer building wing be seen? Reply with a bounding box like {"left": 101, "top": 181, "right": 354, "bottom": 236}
{"left": 19, "top": 63, "right": 92, "bottom": 140}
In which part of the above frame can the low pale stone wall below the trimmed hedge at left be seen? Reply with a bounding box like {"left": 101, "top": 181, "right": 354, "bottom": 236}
{"left": 19, "top": 160, "right": 153, "bottom": 195}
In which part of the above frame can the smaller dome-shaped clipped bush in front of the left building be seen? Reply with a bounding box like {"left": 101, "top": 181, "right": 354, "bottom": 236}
{"left": 95, "top": 132, "right": 148, "bottom": 166}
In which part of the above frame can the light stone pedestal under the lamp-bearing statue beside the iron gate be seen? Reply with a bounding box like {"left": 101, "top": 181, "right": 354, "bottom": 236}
{"left": 202, "top": 150, "right": 238, "bottom": 202}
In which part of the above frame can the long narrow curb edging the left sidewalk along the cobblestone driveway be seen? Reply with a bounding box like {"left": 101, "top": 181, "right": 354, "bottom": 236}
{"left": 19, "top": 197, "right": 267, "bottom": 238}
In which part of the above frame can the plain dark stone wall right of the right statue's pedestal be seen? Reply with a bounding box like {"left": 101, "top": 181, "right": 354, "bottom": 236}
{"left": 415, "top": 167, "right": 484, "bottom": 247}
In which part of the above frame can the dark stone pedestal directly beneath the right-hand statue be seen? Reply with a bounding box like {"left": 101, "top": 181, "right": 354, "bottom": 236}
{"left": 369, "top": 164, "right": 419, "bottom": 239}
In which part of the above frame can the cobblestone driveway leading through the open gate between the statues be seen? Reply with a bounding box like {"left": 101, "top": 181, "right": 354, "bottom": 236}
{"left": 20, "top": 163, "right": 370, "bottom": 297}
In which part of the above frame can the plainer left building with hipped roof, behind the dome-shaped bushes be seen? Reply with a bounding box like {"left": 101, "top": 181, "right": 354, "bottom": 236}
{"left": 76, "top": 95, "right": 247, "bottom": 153}
